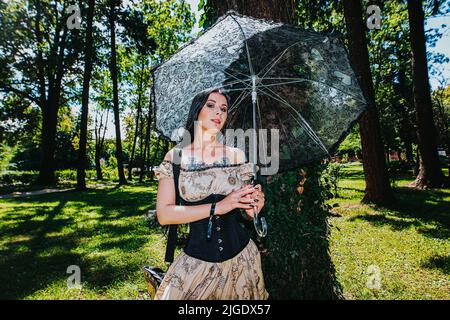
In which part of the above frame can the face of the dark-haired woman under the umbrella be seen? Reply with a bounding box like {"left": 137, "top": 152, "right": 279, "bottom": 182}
{"left": 197, "top": 92, "right": 228, "bottom": 134}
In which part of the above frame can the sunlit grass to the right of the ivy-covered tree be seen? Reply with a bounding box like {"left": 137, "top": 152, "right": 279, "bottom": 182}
{"left": 329, "top": 164, "right": 450, "bottom": 299}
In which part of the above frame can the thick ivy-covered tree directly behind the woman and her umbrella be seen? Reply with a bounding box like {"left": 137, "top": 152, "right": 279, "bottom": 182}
{"left": 202, "top": 0, "right": 340, "bottom": 299}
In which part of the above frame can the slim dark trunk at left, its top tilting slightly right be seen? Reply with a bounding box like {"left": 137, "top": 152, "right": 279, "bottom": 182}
{"left": 77, "top": 0, "right": 95, "bottom": 190}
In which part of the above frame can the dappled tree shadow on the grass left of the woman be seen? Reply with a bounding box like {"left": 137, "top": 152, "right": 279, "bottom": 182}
{"left": 0, "top": 188, "right": 155, "bottom": 299}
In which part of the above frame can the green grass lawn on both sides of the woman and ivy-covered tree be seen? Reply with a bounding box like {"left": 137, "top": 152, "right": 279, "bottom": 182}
{"left": 0, "top": 165, "right": 450, "bottom": 299}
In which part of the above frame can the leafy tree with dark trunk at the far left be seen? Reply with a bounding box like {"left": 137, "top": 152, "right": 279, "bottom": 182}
{"left": 0, "top": 0, "right": 80, "bottom": 184}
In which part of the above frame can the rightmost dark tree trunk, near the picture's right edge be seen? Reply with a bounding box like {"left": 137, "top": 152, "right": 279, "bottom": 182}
{"left": 408, "top": 0, "right": 445, "bottom": 188}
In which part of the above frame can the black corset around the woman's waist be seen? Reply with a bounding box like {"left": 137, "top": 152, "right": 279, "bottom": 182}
{"left": 181, "top": 194, "right": 250, "bottom": 262}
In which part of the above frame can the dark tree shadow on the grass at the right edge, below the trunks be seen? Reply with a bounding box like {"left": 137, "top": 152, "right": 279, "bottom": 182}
{"left": 350, "top": 187, "right": 450, "bottom": 239}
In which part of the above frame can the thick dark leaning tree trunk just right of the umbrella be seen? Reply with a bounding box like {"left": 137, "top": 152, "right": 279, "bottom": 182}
{"left": 344, "top": 0, "right": 395, "bottom": 205}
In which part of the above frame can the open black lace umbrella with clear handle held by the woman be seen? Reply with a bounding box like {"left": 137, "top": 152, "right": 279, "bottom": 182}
{"left": 152, "top": 11, "right": 366, "bottom": 237}
